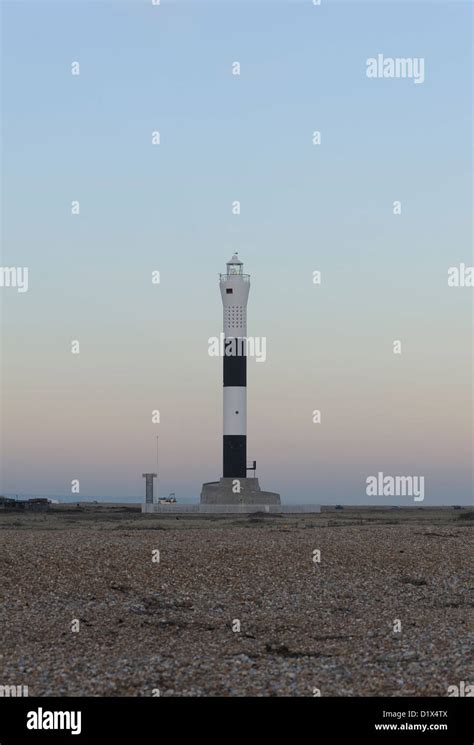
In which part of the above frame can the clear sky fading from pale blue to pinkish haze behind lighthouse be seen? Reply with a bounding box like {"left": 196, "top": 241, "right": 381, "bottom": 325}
{"left": 0, "top": 0, "right": 472, "bottom": 503}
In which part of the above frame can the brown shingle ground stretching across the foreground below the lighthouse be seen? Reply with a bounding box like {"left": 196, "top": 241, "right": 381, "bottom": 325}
{"left": 0, "top": 508, "right": 474, "bottom": 696}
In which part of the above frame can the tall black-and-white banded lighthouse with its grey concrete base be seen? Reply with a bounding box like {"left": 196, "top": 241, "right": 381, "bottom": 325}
{"left": 201, "top": 253, "right": 280, "bottom": 505}
